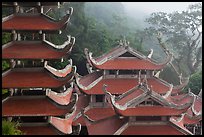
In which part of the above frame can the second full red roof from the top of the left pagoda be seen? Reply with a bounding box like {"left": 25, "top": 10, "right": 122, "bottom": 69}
{"left": 2, "top": 38, "right": 74, "bottom": 59}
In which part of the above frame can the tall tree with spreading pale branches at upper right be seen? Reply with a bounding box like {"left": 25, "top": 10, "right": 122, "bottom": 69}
{"left": 146, "top": 3, "right": 202, "bottom": 75}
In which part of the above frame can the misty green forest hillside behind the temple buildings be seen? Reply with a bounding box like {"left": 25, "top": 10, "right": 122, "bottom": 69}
{"left": 2, "top": 2, "right": 202, "bottom": 94}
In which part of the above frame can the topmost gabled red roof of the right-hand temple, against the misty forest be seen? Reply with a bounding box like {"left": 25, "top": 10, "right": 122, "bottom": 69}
{"left": 85, "top": 43, "right": 172, "bottom": 70}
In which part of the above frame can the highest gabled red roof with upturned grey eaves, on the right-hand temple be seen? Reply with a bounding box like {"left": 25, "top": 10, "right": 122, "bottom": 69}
{"left": 84, "top": 46, "right": 172, "bottom": 70}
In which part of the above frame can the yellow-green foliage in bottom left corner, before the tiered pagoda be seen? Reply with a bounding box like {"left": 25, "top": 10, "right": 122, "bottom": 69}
{"left": 2, "top": 120, "right": 23, "bottom": 135}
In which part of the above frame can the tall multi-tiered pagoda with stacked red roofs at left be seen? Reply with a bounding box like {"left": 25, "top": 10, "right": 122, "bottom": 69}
{"left": 2, "top": 2, "right": 81, "bottom": 135}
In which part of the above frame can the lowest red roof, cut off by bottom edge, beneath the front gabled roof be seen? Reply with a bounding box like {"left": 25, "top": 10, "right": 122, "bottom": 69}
{"left": 82, "top": 108, "right": 191, "bottom": 135}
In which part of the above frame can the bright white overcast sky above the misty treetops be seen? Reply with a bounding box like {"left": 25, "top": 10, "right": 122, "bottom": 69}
{"left": 122, "top": 2, "right": 202, "bottom": 14}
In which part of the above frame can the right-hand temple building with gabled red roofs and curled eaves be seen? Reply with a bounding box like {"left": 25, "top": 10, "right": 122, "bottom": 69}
{"left": 75, "top": 40, "right": 202, "bottom": 135}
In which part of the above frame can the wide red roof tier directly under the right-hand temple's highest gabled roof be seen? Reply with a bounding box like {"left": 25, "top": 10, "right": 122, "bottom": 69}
{"left": 78, "top": 72, "right": 177, "bottom": 94}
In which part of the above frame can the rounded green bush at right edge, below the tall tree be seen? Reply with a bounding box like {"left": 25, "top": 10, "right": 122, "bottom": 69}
{"left": 184, "top": 71, "right": 202, "bottom": 95}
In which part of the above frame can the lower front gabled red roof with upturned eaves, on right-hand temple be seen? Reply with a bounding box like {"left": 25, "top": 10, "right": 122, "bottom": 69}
{"left": 103, "top": 82, "right": 193, "bottom": 116}
